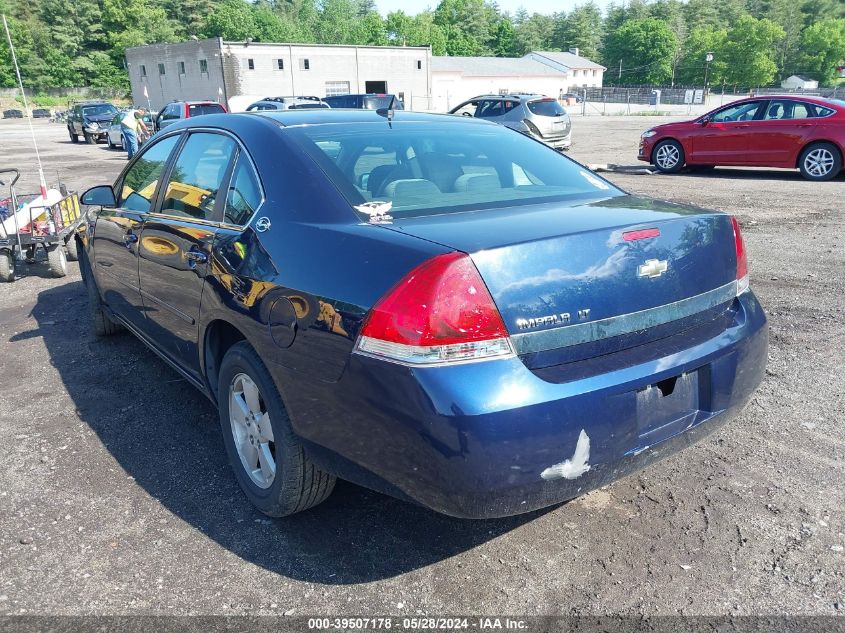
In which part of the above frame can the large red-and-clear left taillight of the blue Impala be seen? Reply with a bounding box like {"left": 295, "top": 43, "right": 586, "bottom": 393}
{"left": 357, "top": 252, "right": 514, "bottom": 365}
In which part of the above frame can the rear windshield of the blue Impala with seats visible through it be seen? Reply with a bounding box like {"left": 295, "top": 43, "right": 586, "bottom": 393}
{"left": 287, "top": 120, "right": 621, "bottom": 219}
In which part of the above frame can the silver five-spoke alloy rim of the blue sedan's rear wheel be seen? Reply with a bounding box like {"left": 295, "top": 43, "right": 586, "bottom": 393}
{"left": 229, "top": 373, "right": 276, "bottom": 489}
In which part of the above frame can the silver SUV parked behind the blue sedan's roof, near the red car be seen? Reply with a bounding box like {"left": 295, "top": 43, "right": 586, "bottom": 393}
{"left": 449, "top": 93, "right": 572, "bottom": 150}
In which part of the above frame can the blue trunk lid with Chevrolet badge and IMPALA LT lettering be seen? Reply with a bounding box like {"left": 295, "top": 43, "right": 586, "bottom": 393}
{"left": 380, "top": 196, "right": 736, "bottom": 367}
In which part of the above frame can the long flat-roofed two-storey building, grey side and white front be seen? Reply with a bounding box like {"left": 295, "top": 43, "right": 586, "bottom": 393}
{"left": 126, "top": 38, "right": 431, "bottom": 111}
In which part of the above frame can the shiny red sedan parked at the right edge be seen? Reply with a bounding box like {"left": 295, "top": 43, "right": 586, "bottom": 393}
{"left": 638, "top": 96, "right": 845, "bottom": 180}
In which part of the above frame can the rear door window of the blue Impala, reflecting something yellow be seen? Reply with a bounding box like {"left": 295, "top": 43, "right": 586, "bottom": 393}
{"left": 160, "top": 132, "right": 237, "bottom": 220}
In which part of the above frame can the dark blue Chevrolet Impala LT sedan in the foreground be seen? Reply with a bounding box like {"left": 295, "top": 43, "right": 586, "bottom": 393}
{"left": 80, "top": 110, "right": 767, "bottom": 517}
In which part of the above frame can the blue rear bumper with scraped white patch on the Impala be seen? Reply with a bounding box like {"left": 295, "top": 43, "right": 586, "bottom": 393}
{"left": 285, "top": 292, "right": 768, "bottom": 518}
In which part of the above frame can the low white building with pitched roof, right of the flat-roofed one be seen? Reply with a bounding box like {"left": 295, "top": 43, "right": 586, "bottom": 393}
{"left": 431, "top": 51, "right": 605, "bottom": 112}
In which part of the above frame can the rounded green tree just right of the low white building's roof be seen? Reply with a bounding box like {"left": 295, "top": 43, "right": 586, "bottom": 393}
{"left": 604, "top": 18, "right": 678, "bottom": 84}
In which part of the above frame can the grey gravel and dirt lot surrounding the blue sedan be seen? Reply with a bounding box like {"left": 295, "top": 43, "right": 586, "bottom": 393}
{"left": 0, "top": 117, "right": 845, "bottom": 615}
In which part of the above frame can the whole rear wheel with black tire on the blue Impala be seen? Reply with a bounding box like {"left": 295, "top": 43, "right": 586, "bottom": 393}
{"left": 217, "top": 341, "right": 336, "bottom": 517}
